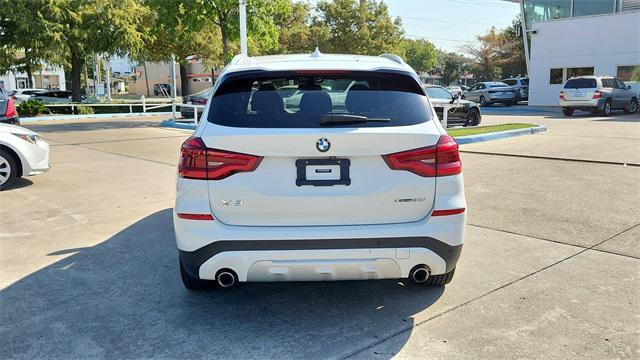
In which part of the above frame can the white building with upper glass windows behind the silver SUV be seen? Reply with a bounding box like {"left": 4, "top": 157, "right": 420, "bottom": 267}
{"left": 506, "top": 0, "right": 640, "bottom": 106}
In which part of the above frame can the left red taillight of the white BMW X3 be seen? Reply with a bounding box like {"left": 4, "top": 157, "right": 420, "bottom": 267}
{"left": 178, "top": 137, "right": 262, "bottom": 180}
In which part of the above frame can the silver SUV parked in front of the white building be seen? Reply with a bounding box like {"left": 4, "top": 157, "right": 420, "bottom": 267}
{"left": 559, "top": 76, "right": 638, "bottom": 116}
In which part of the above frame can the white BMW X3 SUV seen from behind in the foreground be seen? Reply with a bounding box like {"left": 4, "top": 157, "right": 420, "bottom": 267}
{"left": 174, "top": 51, "right": 466, "bottom": 290}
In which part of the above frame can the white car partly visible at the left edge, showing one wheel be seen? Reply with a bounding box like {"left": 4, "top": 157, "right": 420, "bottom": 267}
{"left": 0, "top": 124, "right": 49, "bottom": 190}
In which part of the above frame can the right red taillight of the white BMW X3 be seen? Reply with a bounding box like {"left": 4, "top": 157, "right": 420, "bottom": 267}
{"left": 382, "top": 135, "right": 462, "bottom": 177}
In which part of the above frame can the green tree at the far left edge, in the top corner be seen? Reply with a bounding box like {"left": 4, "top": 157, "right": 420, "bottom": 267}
{"left": 0, "top": 0, "right": 61, "bottom": 87}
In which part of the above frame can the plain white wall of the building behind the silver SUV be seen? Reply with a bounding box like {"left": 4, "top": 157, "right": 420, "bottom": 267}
{"left": 529, "top": 12, "right": 640, "bottom": 106}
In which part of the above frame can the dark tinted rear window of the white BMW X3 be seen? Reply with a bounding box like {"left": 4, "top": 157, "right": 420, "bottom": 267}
{"left": 208, "top": 71, "right": 431, "bottom": 128}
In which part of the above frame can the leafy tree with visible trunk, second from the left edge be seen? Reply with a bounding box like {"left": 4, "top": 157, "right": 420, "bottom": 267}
{"left": 39, "top": 0, "right": 148, "bottom": 101}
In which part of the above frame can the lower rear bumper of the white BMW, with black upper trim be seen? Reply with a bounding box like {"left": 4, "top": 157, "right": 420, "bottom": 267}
{"left": 179, "top": 237, "right": 462, "bottom": 281}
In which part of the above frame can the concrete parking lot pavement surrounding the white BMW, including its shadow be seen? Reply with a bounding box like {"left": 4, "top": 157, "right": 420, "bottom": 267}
{"left": 0, "top": 110, "right": 640, "bottom": 359}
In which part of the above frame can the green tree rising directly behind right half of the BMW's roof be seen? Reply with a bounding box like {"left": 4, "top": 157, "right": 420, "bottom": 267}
{"left": 310, "top": 0, "right": 403, "bottom": 55}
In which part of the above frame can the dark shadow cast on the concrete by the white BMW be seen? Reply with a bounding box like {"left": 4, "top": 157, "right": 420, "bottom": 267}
{"left": 0, "top": 209, "right": 443, "bottom": 359}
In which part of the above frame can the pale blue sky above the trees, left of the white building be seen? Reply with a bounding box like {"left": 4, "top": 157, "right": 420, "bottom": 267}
{"left": 310, "top": 0, "right": 520, "bottom": 52}
